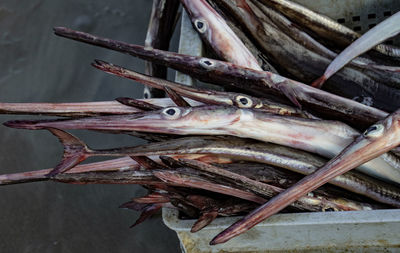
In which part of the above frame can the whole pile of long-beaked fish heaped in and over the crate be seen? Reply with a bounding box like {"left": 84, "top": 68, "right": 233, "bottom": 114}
{"left": 0, "top": 0, "right": 400, "bottom": 244}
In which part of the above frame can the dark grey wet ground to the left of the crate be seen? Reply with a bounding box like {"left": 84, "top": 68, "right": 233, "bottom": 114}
{"left": 0, "top": 0, "right": 179, "bottom": 253}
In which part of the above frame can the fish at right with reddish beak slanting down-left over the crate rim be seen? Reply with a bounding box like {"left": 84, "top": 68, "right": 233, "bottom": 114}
{"left": 210, "top": 107, "right": 400, "bottom": 245}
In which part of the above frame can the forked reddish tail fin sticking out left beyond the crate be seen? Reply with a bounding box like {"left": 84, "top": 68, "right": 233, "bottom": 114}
{"left": 46, "top": 128, "right": 90, "bottom": 177}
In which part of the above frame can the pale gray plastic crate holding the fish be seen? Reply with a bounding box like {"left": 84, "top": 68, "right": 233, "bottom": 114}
{"left": 163, "top": 0, "right": 400, "bottom": 253}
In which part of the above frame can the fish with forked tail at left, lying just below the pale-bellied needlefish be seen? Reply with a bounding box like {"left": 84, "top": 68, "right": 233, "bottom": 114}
{"left": 4, "top": 129, "right": 400, "bottom": 207}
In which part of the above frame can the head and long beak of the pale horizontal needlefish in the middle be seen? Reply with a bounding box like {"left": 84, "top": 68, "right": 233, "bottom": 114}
{"left": 4, "top": 106, "right": 240, "bottom": 135}
